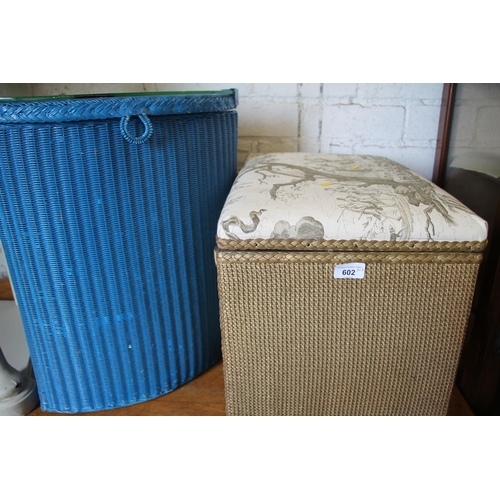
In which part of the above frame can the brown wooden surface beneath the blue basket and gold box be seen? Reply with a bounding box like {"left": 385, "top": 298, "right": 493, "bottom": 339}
{"left": 0, "top": 280, "right": 473, "bottom": 416}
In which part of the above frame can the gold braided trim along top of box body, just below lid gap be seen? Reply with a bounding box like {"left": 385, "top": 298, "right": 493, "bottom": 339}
{"left": 215, "top": 250, "right": 483, "bottom": 264}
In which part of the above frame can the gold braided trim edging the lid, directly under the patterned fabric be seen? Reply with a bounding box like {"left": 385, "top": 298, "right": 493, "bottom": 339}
{"left": 217, "top": 237, "right": 488, "bottom": 252}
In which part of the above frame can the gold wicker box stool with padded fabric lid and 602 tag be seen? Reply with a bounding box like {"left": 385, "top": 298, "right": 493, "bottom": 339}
{"left": 216, "top": 153, "right": 487, "bottom": 415}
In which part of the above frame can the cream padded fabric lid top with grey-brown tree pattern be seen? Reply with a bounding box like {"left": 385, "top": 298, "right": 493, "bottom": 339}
{"left": 217, "top": 153, "right": 487, "bottom": 242}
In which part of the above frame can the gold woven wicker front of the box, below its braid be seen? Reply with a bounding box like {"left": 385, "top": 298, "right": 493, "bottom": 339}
{"left": 217, "top": 252, "right": 480, "bottom": 415}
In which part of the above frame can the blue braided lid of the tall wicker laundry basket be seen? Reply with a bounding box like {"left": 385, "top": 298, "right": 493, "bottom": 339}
{"left": 0, "top": 89, "right": 238, "bottom": 123}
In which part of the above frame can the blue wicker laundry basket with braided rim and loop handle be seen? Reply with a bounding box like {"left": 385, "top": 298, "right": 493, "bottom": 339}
{"left": 0, "top": 90, "right": 237, "bottom": 413}
